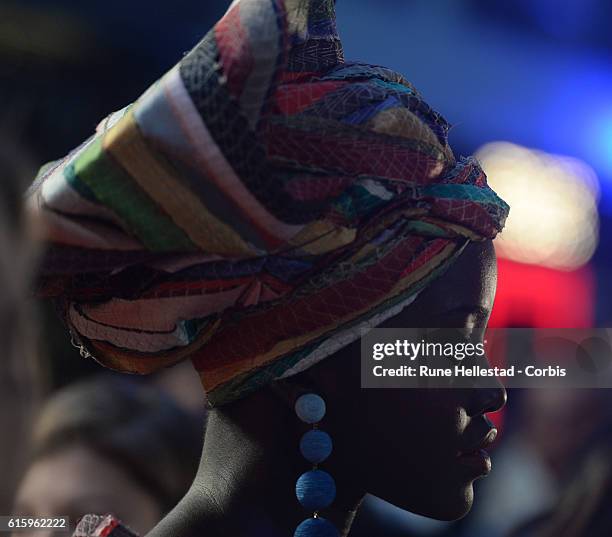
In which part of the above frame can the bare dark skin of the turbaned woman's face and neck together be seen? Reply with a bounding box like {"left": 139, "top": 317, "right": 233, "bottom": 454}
{"left": 149, "top": 241, "right": 506, "bottom": 537}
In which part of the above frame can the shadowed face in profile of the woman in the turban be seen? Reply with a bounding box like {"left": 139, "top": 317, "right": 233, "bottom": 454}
{"left": 316, "top": 241, "right": 506, "bottom": 520}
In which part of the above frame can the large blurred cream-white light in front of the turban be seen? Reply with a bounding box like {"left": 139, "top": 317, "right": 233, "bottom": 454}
{"left": 476, "top": 142, "right": 599, "bottom": 270}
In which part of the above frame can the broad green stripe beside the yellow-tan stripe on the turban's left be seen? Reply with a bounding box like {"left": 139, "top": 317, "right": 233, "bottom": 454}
{"left": 73, "top": 137, "right": 197, "bottom": 252}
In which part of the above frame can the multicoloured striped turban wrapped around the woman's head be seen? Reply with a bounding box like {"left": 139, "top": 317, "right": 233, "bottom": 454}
{"left": 29, "top": 0, "right": 508, "bottom": 406}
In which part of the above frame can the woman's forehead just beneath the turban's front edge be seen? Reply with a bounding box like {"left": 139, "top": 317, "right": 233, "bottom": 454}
{"left": 384, "top": 240, "right": 497, "bottom": 328}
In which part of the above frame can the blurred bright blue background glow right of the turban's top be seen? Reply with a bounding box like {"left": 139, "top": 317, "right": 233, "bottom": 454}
{"left": 338, "top": 0, "right": 612, "bottom": 215}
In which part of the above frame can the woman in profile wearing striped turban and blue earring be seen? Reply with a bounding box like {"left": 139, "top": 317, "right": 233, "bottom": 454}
{"left": 31, "top": 0, "right": 508, "bottom": 536}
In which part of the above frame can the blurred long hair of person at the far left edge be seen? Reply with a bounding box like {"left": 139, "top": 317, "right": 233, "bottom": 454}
{"left": 0, "top": 129, "right": 39, "bottom": 513}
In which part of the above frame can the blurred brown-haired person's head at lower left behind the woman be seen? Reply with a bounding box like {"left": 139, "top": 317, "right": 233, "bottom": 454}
{"left": 15, "top": 375, "right": 203, "bottom": 537}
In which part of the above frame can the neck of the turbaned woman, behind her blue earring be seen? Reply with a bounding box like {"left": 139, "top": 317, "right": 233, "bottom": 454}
{"left": 148, "top": 393, "right": 363, "bottom": 537}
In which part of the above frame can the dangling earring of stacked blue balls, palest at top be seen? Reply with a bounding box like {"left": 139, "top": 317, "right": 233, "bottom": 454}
{"left": 294, "top": 393, "right": 340, "bottom": 537}
